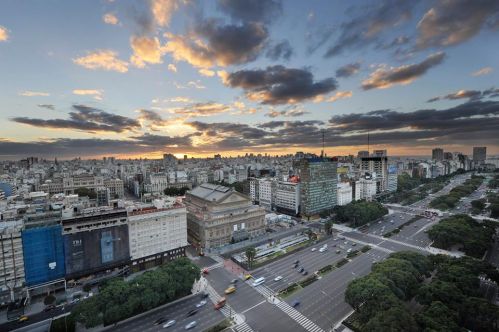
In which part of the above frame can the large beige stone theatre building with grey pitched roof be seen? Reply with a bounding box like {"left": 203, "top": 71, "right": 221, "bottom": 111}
{"left": 184, "top": 183, "right": 265, "bottom": 248}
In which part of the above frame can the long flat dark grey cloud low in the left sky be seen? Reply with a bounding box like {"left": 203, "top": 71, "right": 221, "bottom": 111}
{"left": 11, "top": 105, "right": 140, "bottom": 133}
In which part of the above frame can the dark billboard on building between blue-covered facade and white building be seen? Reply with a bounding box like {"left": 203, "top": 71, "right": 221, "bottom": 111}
{"left": 64, "top": 225, "right": 130, "bottom": 278}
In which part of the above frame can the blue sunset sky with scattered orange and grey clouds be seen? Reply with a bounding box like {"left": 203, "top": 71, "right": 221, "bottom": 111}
{"left": 0, "top": 0, "right": 499, "bottom": 159}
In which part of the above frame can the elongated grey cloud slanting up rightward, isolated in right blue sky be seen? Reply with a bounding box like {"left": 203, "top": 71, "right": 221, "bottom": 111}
{"left": 362, "top": 52, "right": 445, "bottom": 90}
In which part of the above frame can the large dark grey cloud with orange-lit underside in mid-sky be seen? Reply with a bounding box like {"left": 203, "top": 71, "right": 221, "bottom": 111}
{"left": 224, "top": 66, "right": 337, "bottom": 105}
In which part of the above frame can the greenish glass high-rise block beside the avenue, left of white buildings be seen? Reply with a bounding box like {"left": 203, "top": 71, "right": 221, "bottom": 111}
{"left": 294, "top": 157, "right": 338, "bottom": 217}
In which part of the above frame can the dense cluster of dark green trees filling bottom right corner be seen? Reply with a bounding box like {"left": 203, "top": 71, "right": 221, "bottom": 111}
{"left": 344, "top": 252, "right": 499, "bottom": 332}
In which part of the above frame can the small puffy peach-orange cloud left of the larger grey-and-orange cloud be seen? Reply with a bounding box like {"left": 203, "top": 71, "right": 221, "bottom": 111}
{"left": 130, "top": 36, "right": 164, "bottom": 68}
